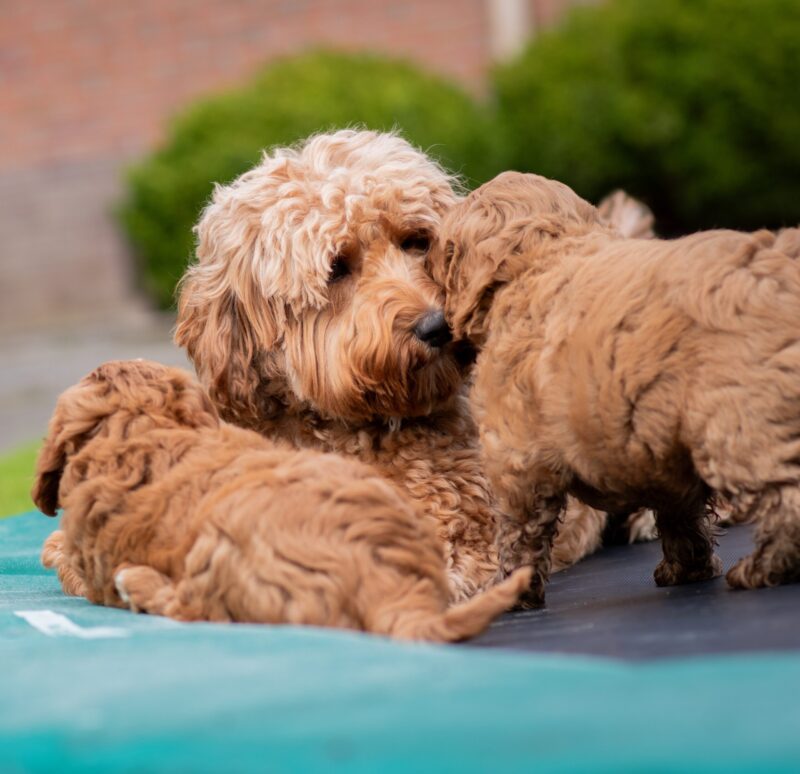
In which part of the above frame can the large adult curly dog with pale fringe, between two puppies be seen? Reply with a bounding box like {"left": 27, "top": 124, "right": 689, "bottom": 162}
{"left": 176, "top": 130, "right": 620, "bottom": 600}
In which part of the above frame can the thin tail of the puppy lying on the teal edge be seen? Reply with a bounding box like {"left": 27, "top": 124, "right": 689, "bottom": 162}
{"left": 389, "top": 567, "right": 531, "bottom": 642}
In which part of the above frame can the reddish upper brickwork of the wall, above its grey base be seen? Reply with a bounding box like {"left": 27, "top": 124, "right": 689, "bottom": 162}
{"left": 0, "top": 0, "right": 494, "bottom": 169}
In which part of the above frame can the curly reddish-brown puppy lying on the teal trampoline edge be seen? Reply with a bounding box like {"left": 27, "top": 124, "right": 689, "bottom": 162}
{"left": 33, "top": 361, "right": 530, "bottom": 641}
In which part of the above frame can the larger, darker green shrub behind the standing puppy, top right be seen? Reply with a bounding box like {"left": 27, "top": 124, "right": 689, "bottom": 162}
{"left": 494, "top": 0, "right": 800, "bottom": 232}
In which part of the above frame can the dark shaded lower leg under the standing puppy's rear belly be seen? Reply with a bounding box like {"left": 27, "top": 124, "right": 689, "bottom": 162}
{"left": 654, "top": 485, "right": 722, "bottom": 586}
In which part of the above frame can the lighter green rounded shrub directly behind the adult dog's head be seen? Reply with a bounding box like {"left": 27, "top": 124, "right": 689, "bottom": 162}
{"left": 121, "top": 52, "right": 497, "bottom": 306}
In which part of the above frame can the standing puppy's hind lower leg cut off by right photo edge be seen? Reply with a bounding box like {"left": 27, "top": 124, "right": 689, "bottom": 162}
{"left": 726, "top": 486, "right": 800, "bottom": 589}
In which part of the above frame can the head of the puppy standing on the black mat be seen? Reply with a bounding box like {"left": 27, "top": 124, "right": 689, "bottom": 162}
{"left": 428, "top": 172, "right": 601, "bottom": 347}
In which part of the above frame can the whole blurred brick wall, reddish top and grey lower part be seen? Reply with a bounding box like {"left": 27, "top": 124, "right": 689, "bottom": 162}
{"left": 0, "top": 0, "right": 592, "bottom": 328}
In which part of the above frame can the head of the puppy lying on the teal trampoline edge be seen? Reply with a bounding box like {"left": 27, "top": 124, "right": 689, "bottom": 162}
{"left": 31, "top": 360, "right": 219, "bottom": 516}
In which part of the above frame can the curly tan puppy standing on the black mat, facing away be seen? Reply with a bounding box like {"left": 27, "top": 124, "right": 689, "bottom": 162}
{"left": 431, "top": 173, "right": 800, "bottom": 603}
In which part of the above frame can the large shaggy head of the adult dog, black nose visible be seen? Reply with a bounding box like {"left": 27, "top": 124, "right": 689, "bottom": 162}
{"left": 176, "top": 130, "right": 462, "bottom": 425}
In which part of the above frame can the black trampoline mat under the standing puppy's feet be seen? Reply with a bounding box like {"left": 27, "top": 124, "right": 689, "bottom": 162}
{"left": 466, "top": 526, "right": 800, "bottom": 660}
